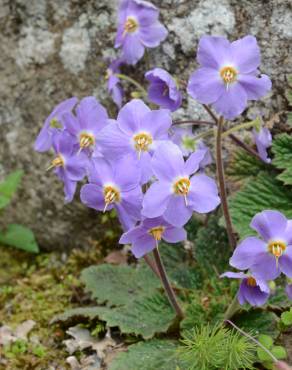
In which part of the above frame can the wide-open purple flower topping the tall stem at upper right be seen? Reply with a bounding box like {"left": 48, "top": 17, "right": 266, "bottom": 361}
{"left": 188, "top": 36, "right": 272, "bottom": 119}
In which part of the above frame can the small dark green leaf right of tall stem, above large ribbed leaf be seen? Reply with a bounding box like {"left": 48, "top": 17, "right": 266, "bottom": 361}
{"left": 226, "top": 149, "right": 269, "bottom": 181}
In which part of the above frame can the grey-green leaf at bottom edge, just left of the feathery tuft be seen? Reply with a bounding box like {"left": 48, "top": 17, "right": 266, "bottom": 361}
{"left": 109, "top": 339, "right": 180, "bottom": 370}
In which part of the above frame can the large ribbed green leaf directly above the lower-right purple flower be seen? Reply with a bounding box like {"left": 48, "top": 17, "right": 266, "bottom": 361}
{"left": 229, "top": 172, "right": 292, "bottom": 238}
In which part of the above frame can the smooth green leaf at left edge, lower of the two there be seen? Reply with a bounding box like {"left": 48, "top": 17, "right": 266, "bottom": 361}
{"left": 0, "top": 224, "right": 39, "bottom": 253}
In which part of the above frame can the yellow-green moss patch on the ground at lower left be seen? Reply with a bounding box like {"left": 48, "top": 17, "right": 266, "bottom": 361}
{"left": 0, "top": 246, "right": 101, "bottom": 370}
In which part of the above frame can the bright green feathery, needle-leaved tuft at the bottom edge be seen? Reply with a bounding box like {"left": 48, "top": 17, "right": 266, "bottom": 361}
{"left": 179, "top": 324, "right": 255, "bottom": 370}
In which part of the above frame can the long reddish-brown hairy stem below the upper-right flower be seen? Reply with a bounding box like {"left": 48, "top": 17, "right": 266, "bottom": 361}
{"left": 216, "top": 117, "right": 236, "bottom": 250}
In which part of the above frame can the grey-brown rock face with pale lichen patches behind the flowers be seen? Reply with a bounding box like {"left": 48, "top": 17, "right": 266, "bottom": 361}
{"left": 0, "top": 0, "right": 292, "bottom": 249}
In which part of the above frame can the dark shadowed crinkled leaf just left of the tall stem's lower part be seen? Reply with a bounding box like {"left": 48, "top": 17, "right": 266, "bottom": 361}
{"left": 194, "top": 215, "right": 231, "bottom": 278}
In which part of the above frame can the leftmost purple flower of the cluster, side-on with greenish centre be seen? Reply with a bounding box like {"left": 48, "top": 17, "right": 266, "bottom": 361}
{"left": 34, "top": 97, "right": 78, "bottom": 152}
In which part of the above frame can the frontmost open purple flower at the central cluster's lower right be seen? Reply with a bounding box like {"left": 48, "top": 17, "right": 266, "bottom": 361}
{"left": 142, "top": 142, "right": 220, "bottom": 227}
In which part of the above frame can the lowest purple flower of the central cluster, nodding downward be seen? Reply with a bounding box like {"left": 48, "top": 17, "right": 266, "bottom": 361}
{"left": 119, "top": 217, "right": 187, "bottom": 258}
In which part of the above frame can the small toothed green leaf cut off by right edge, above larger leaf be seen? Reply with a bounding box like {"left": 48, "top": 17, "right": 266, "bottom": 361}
{"left": 272, "top": 134, "right": 292, "bottom": 185}
